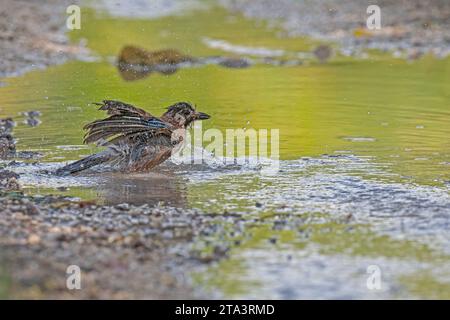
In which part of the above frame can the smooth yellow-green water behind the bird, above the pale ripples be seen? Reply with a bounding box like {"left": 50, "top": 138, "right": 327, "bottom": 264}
{"left": 0, "top": 10, "right": 450, "bottom": 183}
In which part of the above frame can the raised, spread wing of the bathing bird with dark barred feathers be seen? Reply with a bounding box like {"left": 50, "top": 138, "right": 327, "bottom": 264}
{"left": 84, "top": 100, "right": 171, "bottom": 144}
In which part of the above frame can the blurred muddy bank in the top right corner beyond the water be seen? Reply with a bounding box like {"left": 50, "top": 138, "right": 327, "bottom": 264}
{"left": 220, "top": 0, "right": 450, "bottom": 59}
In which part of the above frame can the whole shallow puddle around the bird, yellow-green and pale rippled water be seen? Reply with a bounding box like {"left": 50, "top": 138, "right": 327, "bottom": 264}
{"left": 0, "top": 1, "right": 450, "bottom": 298}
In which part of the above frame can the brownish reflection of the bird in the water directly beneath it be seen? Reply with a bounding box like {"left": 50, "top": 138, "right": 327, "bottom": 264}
{"left": 99, "top": 172, "right": 186, "bottom": 208}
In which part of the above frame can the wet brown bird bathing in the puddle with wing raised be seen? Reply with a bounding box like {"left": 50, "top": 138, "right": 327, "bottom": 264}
{"left": 56, "top": 100, "right": 210, "bottom": 175}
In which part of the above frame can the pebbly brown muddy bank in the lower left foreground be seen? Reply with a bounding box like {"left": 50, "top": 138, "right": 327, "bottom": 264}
{"left": 0, "top": 189, "right": 225, "bottom": 299}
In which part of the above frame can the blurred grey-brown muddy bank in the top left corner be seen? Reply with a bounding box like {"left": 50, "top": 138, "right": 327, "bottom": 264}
{"left": 0, "top": 0, "right": 87, "bottom": 77}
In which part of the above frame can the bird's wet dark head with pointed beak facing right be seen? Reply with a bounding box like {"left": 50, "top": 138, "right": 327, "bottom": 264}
{"left": 161, "top": 102, "right": 210, "bottom": 128}
